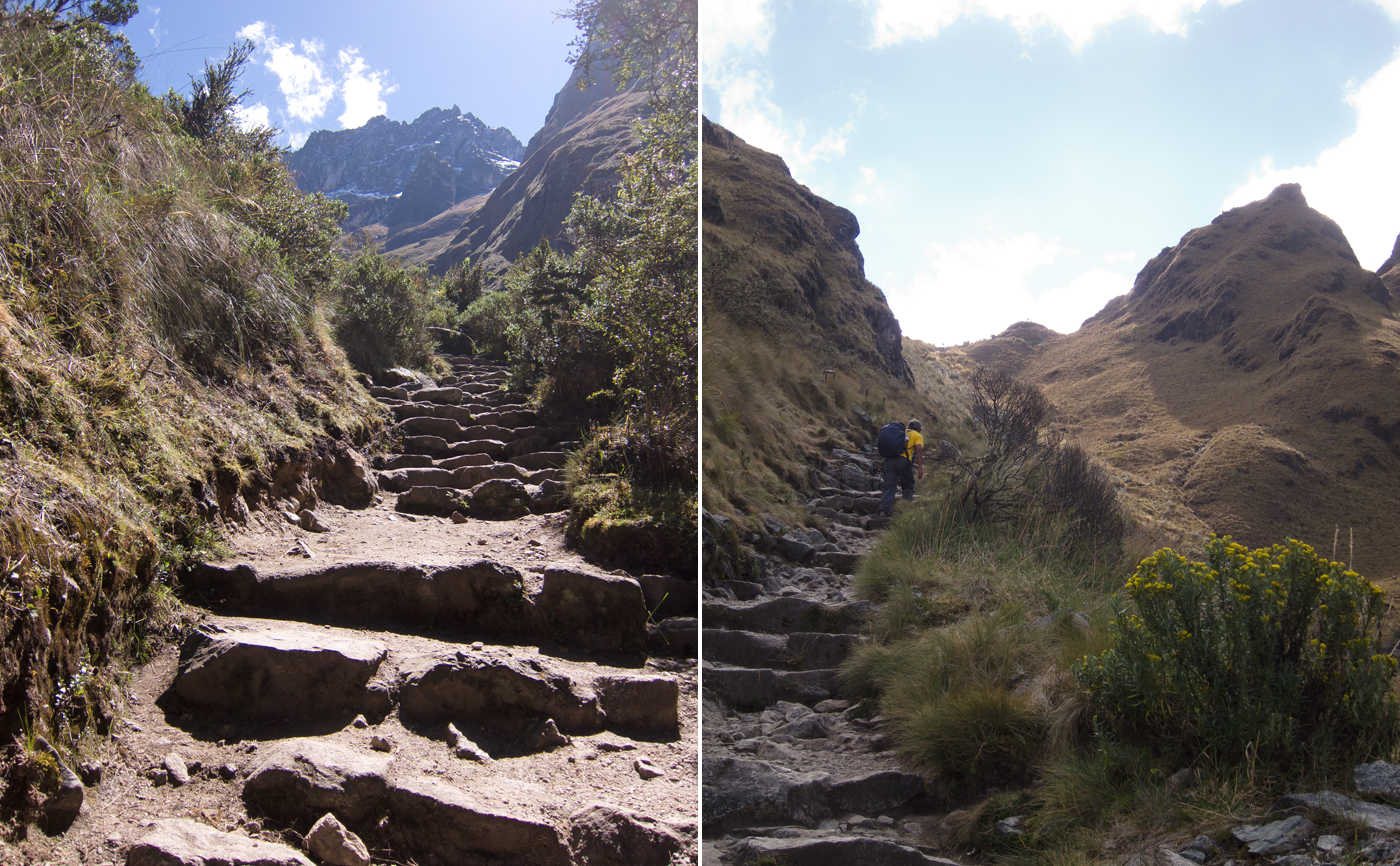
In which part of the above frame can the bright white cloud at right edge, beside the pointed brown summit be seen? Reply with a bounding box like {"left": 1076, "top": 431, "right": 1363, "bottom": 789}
{"left": 1221, "top": 48, "right": 1400, "bottom": 267}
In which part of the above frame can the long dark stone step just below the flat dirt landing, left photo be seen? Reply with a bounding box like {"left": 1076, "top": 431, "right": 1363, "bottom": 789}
{"left": 186, "top": 560, "right": 647, "bottom": 653}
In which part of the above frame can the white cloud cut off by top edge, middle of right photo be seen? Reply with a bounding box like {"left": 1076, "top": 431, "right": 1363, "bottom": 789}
{"left": 867, "top": 0, "right": 1248, "bottom": 50}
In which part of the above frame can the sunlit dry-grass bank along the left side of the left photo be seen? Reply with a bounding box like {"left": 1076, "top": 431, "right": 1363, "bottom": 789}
{"left": 0, "top": 8, "right": 382, "bottom": 811}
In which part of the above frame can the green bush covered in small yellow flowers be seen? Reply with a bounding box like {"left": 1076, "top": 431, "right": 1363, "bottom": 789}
{"left": 1075, "top": 536, "right": 1400, "bottom": 767}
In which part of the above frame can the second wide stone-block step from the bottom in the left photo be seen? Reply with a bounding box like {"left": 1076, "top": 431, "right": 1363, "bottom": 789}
{"left": 172, "top": 617, "right": 680, "bottom": 737}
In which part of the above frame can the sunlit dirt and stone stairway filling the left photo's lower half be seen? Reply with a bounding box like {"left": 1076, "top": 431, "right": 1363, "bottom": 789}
{"left": 13, "top": 358, "right": 697, "bottom": 866}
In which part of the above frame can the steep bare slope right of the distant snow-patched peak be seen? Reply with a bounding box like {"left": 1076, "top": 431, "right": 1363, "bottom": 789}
{"left": 428, "top": 64, "right": 647, "bottom": 273}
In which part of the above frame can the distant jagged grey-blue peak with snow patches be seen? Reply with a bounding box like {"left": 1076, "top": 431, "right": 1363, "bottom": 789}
{"left": 287, "top": 105, "right": 525, "bottom": 225}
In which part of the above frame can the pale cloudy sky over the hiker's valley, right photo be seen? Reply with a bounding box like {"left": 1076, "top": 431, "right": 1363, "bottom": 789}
{"left": 700, "top": 0, "right": 1400, "bottom": 346}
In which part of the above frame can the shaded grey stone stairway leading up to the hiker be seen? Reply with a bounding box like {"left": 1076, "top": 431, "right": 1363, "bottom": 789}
{"left": 701, "top": 449, "right": 949, "bottom": 866}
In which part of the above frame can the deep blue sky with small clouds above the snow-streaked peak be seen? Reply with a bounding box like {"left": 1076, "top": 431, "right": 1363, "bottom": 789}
{"left": 125, "top": 0, "right": 577, "bottom": 147}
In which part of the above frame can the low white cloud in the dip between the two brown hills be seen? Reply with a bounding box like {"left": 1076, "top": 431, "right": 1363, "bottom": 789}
{"left": 888, "top": 232, "right": 1133, "bottom": 346}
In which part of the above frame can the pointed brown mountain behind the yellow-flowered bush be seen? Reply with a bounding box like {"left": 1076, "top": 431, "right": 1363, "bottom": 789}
{"left": 967, "top": 185, "right": 1400, "bottom": 579}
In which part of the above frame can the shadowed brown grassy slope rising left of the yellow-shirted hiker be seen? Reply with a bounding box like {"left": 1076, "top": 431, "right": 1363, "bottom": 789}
{"left": 701, "top": 120, "right": 966, "bottom": 523}
